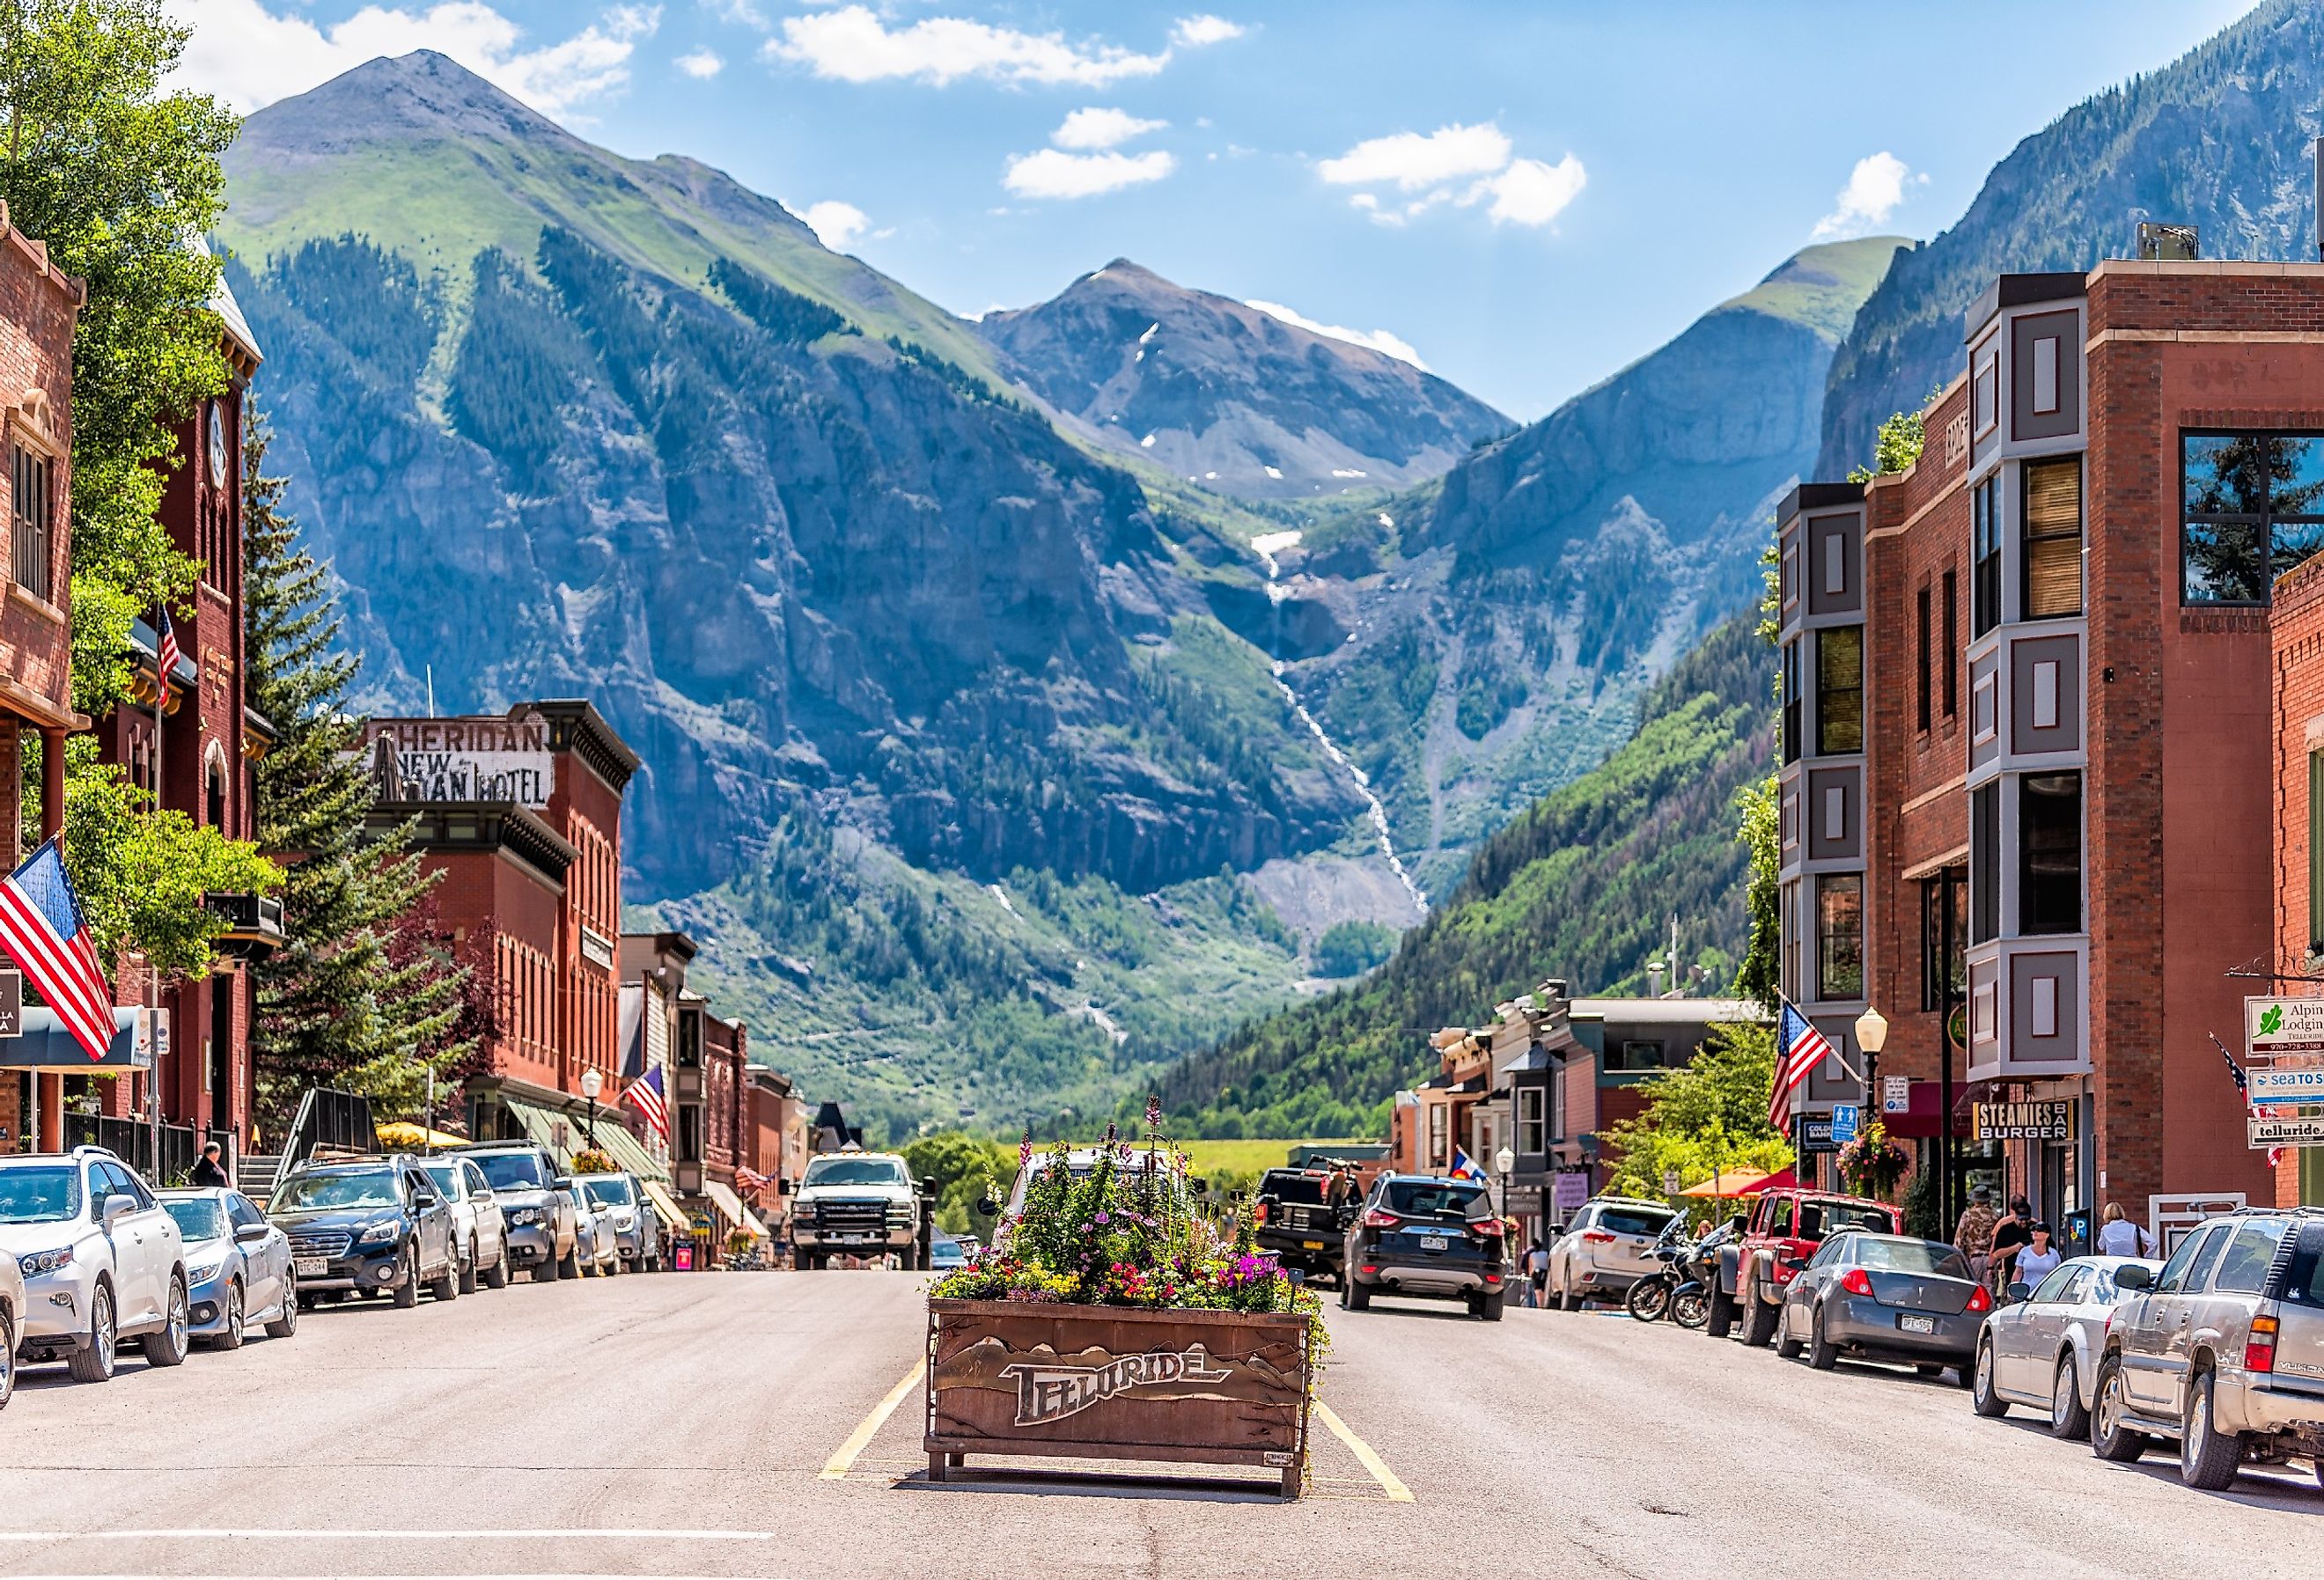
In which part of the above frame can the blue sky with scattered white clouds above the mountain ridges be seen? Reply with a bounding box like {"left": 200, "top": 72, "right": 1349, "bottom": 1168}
{"left": 165, "top": 0, "right": 2250, "bottom": 418}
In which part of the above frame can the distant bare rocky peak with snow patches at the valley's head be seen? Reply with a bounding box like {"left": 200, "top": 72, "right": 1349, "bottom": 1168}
{"left": 976, "top": 258, "right": 1513, "bottom": 500}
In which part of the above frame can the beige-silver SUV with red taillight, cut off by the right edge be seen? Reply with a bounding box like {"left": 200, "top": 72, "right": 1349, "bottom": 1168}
{"left": 2089, "top": 1209, "right": 2324, "bottom": 1492}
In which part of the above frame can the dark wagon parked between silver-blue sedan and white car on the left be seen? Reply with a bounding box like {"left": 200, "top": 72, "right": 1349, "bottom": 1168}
{"left": 268, "top": 1152, "right": 460, "bottom": 1306}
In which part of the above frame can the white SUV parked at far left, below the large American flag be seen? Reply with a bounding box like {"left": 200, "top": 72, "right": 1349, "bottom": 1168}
{"left": 0, "top": 1145, "right": 193, "bottom": 1383}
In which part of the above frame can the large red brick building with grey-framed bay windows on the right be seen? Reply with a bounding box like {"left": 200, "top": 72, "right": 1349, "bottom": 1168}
{"left": 1778, "top": 261, "right": 2324, "bottom": 1220}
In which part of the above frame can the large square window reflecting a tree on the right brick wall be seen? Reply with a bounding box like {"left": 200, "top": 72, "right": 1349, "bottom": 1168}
{"left": 2180, "top": 432, "right": 2324, "bottom": 604}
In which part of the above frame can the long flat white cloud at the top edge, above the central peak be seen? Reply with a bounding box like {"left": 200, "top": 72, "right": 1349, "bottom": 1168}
{"left": 765, "top": 4, "right": 1169, "bottom": 88}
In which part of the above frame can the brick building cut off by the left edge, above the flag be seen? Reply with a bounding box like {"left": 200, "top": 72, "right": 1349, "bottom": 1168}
{"left": 0, "top": 207, "right": 88, "bottom": 1148}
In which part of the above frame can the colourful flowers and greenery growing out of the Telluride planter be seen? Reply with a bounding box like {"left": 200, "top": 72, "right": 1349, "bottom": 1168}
{"left": 932, "top": 1099, "right": 1325, "bottom": 1371}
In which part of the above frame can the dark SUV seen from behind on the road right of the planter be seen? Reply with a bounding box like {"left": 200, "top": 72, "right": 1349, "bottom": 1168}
{"left": 1339, "top": 1173, "right": 1508, "bottom": 1322}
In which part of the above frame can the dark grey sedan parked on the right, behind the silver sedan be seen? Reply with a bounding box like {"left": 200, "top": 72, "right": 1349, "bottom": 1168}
{"left": 1776, "top": 1231, "right": 1994, "bottom": 1387}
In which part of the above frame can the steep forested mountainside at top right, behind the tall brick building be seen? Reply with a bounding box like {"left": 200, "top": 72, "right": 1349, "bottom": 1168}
{"left": 1817, "top": 0, "right": 2324, "bottom": 476}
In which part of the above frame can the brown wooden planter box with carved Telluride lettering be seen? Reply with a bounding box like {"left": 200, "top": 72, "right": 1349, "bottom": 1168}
{"left": 927, "top": 1301, "right": 1308, "bottom": 1499}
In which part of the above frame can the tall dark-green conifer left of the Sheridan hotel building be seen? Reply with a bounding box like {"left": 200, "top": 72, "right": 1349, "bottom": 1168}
{"left": 242, "top": 421, "right": 472, "bottom": 1129}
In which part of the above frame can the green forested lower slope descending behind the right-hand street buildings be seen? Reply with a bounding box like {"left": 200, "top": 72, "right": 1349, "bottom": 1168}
{"left": 1162, "top": 616, "right": 1773, "bottom": 1136}
